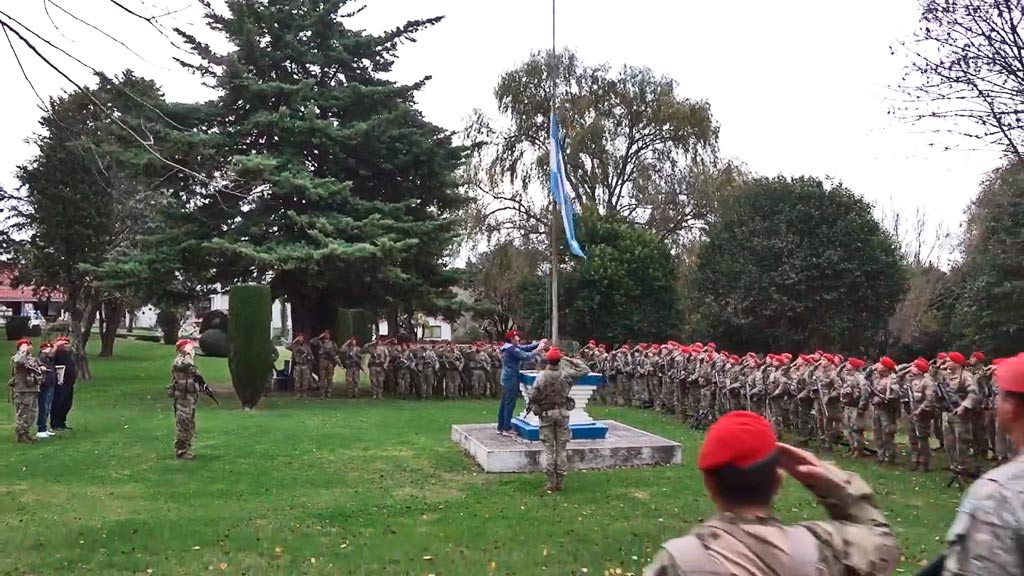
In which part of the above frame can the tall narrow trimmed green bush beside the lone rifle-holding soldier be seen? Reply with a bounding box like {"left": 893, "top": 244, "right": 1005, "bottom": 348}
{"left": 227, "top": 284, "right": 273, "bottom": 408}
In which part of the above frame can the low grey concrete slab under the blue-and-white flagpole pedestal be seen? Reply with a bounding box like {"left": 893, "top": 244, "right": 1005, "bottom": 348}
{"left": 452, "top": 420, "right": 683, "bottom": 472}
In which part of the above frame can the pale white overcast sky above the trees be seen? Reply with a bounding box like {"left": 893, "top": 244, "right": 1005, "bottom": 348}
{"left": 0, "top": 0, "right": 998, "bottom": 262}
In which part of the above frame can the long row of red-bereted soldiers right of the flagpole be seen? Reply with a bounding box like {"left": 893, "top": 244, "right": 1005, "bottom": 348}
{"left": 582, "top": 341, "right": 1013, "bottom": 474}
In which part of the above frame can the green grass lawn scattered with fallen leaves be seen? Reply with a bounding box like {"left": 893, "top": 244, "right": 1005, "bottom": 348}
{"left": 0, "top": 340, "right": 959, "bottom": 575}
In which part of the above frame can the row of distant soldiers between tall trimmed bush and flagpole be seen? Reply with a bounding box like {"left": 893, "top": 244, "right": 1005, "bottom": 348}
{"left": 286, "top": 332, "right": 502, "bottom": 399}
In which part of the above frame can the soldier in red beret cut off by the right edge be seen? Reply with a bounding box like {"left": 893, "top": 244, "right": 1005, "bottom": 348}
{"left": 942, "top": 354, "right": 1024, "bottom": 576}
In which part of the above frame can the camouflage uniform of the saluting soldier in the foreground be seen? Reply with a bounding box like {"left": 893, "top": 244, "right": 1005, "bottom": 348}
{"left": 643, "top": 457, "right": 899, "bottom": 576}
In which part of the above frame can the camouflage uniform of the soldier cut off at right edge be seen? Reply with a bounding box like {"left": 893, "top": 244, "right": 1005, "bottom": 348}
{"left": 942, "top": 456, "right": 1024, "bottom": 576}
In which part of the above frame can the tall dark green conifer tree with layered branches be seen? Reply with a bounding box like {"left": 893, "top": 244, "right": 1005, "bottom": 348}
{"left": 176, "top": 0, "right": 464, "bottom": 334}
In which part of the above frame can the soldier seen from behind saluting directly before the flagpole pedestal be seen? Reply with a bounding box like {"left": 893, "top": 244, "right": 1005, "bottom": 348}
{"left": 529, "top": 348, "right": 590, "bottom": 492}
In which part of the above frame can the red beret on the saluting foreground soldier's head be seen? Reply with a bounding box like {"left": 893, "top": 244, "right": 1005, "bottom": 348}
{"left": 697, "top": 410, "right": 776, "bottom": 471}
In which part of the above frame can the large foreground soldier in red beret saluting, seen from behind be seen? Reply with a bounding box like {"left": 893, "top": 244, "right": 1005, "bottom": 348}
{"left": 644, "top": 411, "right": 900, "bottom": 576}
